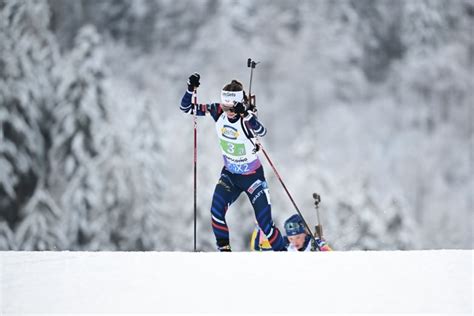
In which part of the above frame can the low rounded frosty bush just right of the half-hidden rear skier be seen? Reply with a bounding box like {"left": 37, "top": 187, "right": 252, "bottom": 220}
{"left": 323, "top": 177, "right": 420, "bottom": 250}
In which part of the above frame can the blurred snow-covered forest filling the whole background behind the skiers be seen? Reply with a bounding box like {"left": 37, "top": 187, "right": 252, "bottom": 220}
{"left": 0, "top": 0, "right": 474, "bottom": 251}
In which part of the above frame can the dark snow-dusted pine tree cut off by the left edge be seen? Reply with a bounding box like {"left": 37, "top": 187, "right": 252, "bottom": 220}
{"left": 0, "top": 1, "right": 59, "bottom": 249}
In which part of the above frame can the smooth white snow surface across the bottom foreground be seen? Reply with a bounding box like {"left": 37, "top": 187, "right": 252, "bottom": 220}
{"left": 0, "top": 250, "right": 474, "bottom": 315}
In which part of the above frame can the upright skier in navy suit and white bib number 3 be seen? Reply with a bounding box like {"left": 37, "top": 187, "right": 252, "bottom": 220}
{"left": 180, "top": 73, "right": 286, "bottom": 251}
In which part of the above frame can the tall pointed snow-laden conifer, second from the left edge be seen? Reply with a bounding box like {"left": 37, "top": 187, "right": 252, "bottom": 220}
{"left": 49, "top": 26, "right": 108, "bottom": 249}
